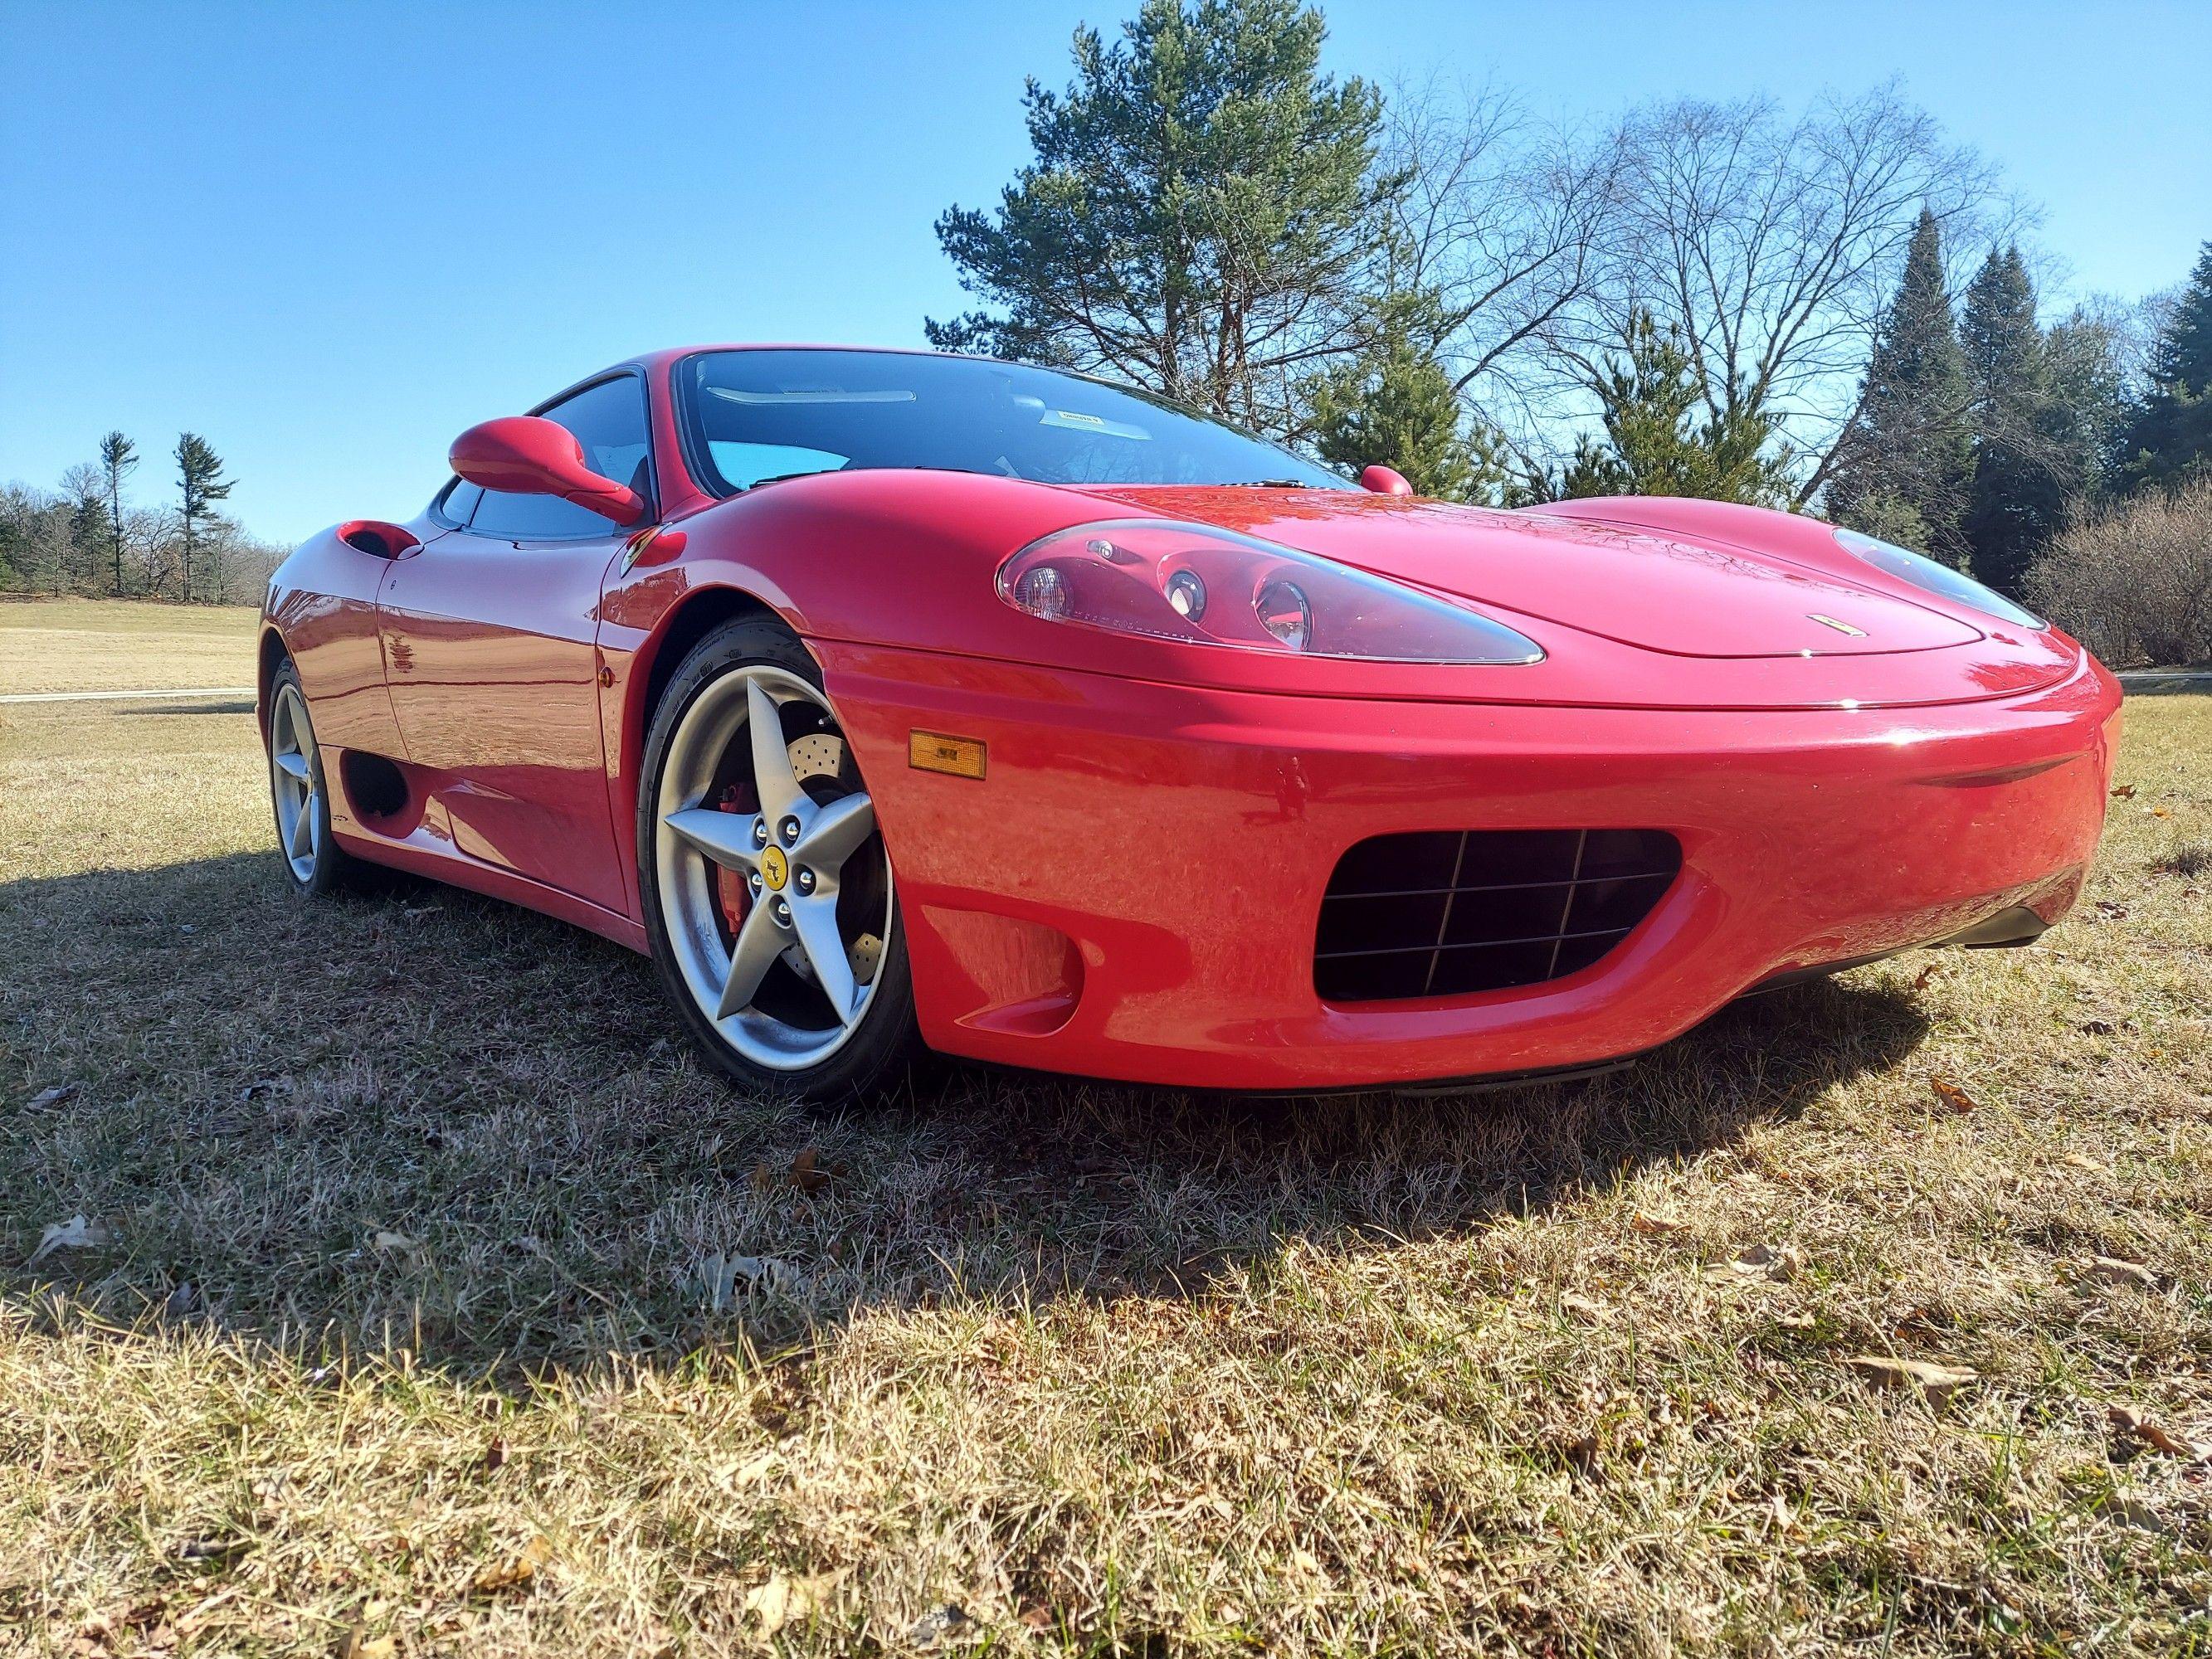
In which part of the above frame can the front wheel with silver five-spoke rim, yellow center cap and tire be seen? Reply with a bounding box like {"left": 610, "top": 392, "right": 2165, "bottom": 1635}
{"left": 637, "top": 620, "right": 916, "bottom": 1099}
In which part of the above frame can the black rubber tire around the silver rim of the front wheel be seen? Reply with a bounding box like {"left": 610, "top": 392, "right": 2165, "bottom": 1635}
{"left": 637, "top": 617, "right": 923, "bottom": 1102}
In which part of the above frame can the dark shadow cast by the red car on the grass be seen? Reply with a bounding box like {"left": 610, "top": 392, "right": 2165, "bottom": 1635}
{"left": 0, "top": 854, "right": 1924, "bottom": 1378}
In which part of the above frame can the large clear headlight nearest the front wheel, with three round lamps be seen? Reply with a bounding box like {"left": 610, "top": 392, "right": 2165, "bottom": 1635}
{"left": 997, "top": 520, "right": 1544, "bottom": 664}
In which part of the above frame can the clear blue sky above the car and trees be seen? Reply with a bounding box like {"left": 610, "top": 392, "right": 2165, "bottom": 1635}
{"left": 0, "top": 0, "right": 2212, "bottom": 540}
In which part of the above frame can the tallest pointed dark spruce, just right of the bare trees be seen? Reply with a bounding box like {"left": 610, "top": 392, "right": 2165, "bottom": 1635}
{"left": 1827, "top": 208, "right": 1973, "bottom": 567}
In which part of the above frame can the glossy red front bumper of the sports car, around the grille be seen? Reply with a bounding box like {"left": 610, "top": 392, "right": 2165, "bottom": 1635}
{"left": 814, "top": 641, "right": 2119, "bottom": 1091}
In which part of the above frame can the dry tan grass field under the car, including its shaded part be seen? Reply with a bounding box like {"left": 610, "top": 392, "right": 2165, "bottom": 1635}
{"left": 0, "top": 611, "right": 2212, "bottom": 1659}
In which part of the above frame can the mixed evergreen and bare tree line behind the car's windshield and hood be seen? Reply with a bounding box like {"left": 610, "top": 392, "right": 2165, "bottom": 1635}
{"left": 924, "top": 0, "right": 2212, "bottom": 653}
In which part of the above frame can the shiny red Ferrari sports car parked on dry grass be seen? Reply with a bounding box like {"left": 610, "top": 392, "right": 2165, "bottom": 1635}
{"left": 261, "top": 348, "right": 2119, "bottom": 1097}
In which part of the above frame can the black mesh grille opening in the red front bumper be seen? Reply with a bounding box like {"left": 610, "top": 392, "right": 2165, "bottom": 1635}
{"left": 1314, "top": 830, "right": 1681, "bottom": 1002}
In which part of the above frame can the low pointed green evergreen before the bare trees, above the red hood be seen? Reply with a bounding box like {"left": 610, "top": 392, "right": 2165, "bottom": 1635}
{"left": 1553, "top": 312, "right": 1791, "bottom": 507}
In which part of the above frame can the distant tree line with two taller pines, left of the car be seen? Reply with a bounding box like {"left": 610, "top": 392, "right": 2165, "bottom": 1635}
{"left": 0, "top": 431, "right": 288, "bottom": 604}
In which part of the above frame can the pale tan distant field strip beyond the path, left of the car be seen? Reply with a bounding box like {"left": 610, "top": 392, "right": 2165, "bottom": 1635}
{"left": 0, "top": 600, "right": 261, "bottom": 694}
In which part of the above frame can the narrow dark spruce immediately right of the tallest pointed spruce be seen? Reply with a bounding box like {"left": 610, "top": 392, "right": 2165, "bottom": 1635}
{"left": 1960, "top": 248, "right": 2068, "bottom": 593}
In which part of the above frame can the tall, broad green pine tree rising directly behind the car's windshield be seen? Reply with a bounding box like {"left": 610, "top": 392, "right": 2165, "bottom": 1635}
{"left": 927, "top": 0, "right": 1407, "bottom": 438}
